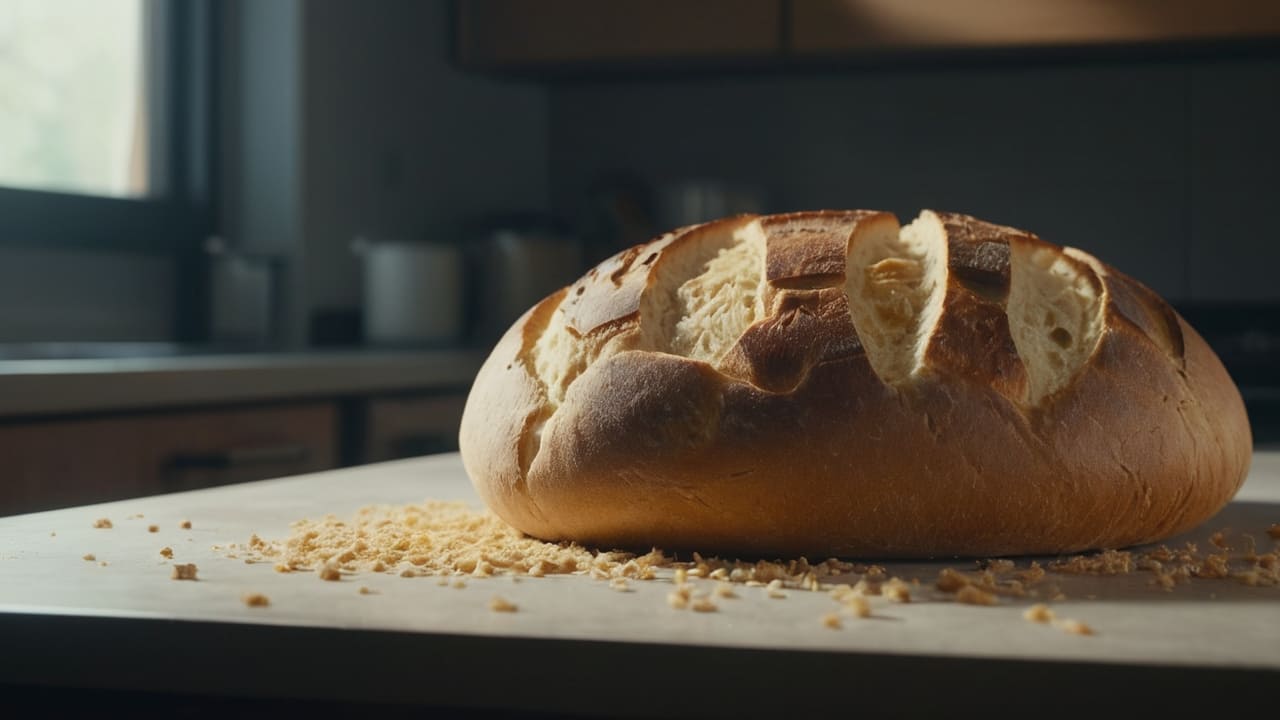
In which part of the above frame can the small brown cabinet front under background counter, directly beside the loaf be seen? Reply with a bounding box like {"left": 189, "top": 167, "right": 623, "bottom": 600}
{"left": 364, "top": 395, "right": 467, "bottom": 462}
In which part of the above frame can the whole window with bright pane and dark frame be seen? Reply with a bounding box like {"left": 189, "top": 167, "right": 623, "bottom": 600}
{"left": 0, "top": 0, "right": 214, "bottom": 252}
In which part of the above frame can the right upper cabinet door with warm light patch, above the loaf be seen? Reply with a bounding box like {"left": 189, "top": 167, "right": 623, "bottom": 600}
{"left": 788, "top": 0, "right": 1280, "bottom": 55}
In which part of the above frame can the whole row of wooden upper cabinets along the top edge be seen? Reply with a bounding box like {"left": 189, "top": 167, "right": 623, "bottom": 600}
{"left": 454, "top": 0, "right": 1280, "bottom": 72}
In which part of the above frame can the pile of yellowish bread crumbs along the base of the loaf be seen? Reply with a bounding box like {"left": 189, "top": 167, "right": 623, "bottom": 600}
{"left": 214, "top": 501, "right": 1280, "bottom": 635}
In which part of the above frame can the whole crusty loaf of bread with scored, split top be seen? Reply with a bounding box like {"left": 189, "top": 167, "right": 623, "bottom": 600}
{"left": 460, "top": 210, "right": 1252, "bottom": 557}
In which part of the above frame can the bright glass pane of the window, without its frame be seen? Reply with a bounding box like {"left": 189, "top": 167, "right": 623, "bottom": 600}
{"left": 0, "top": 0, "right": 155, "bottom": 197}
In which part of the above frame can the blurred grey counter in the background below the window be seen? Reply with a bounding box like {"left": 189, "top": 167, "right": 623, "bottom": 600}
{"left": 0, "top": 350, "right": 485, "bottom": 418}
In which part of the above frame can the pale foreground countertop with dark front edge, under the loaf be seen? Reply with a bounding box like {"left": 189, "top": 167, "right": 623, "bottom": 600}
{"left": 0, "top": 452, "right": 1280, "bottom": 717}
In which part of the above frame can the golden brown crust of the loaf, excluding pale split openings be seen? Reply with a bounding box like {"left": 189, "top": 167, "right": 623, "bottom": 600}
{"left": 461, "top": 211, "right": 1252, "bottom": 557}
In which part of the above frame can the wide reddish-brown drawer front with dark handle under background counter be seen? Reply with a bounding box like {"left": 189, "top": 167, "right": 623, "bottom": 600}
{"left": 0, "top": 401, "right": 338, "bottom": 515}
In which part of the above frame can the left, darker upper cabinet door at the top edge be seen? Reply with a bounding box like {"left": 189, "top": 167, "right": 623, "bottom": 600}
{"left": 457, "top": 0, "right": 782, "bottom": 69}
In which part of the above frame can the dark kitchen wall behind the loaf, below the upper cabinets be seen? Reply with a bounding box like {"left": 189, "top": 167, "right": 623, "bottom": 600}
{"left": 550, "top": 60, "right": 1280, "bottom": 301}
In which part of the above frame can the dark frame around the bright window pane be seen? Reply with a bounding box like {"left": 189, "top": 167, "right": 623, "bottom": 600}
{"left": 0, "top": 0, "right": 218, "bottom": 255}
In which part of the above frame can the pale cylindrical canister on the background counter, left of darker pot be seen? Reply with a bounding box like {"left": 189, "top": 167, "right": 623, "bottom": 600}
{"left": 356, "top": 238, "right": 465, "bottom": 345}
